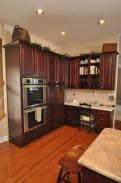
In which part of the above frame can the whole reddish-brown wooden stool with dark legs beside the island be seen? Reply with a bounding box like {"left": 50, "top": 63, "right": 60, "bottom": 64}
{"left": 56, "top": 145, "right": 84, "bottom": 183}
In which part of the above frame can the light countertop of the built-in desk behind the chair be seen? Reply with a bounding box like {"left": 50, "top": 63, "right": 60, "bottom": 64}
{"left": 64, "top": 102, "right": 114, "bottom": 112}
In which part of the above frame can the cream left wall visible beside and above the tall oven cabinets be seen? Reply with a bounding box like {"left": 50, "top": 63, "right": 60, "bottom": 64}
{"left": 0, "top": 23, "right": 61, "bottom": 142}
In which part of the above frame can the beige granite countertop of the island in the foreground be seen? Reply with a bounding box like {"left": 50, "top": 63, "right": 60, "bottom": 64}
{"left": 78, "top": 128, "right": 121, "bottom": 183}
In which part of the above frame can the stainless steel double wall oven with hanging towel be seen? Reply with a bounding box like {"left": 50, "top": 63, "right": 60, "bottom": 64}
{"left": 22, "top": 78, "right": 47, "bottom": 133}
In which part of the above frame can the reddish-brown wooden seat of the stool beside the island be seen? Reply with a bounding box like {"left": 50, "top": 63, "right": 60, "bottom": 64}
{"left": 58, "top": 145, "right": 84, "bottom": 173}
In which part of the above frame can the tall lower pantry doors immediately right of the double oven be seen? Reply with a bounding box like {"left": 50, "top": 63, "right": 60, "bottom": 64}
{"left": 47, "top": 85, "right": 64, "bottom": 130}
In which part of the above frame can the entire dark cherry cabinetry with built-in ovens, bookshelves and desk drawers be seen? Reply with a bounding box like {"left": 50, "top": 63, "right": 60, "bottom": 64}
{"left": 4, "top": 41, "right": 117, "bottom": 146}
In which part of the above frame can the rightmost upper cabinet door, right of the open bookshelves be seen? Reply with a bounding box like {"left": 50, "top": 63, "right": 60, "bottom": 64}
{"left": 100, "top": 53, "right": 116, "bottom": 90}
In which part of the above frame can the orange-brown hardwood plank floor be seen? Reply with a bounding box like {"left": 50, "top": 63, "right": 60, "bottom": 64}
{"left": 0, "top": 126, "right": 97, "bottom": 183}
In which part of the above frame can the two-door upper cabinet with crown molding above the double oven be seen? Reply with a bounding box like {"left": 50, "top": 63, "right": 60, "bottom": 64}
{"left": 5, "top": 41, "right": 47, "bottom": 79}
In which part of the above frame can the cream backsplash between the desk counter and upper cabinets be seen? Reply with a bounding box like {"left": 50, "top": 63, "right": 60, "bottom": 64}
{"left": 65, "top": 89, "right": 116, "bottom": 105}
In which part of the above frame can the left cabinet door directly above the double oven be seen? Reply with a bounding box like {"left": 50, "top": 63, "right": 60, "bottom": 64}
{"left": 20, "top": 45, "right": 36, "bottom": 77}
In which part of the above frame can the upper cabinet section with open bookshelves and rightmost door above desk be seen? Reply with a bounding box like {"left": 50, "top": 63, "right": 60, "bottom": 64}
{"left": 80, "top": 52, "right": 117, "bottom": 90}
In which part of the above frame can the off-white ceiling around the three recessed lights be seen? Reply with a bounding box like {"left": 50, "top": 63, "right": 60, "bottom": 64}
{"left": 0, "top": 0, "right": 121, "bottom": 54}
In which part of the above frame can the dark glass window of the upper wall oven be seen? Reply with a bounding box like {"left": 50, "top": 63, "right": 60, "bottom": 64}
{"left": 27, "top": 87, "right": 44, "bottom": 105}
